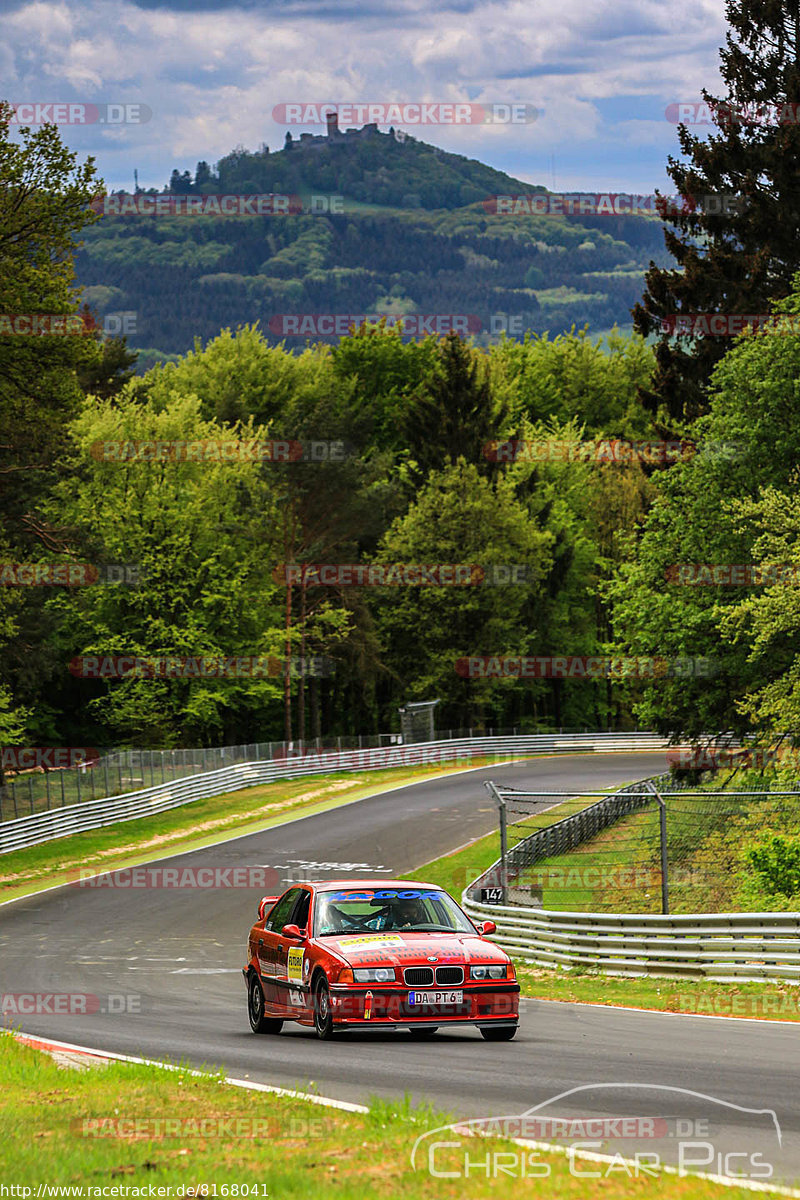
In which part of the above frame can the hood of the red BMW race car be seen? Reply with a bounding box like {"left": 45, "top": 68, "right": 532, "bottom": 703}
{"left": 319, "top": 932, "right": 509, "bottom": 967}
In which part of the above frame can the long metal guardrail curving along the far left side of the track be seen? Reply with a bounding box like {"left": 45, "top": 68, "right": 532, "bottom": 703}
{"left": 0, "top": 733, "right": 669, "bottom": 854}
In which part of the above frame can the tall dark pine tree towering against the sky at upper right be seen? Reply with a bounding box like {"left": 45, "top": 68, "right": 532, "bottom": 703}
{"left": 633, "top": 0, "right": 800, "bottom": 432}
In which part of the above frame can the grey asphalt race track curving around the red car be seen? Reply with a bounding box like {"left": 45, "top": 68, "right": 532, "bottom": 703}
{"left": 0, "top": 754, "right": 800, "bottom": 1184}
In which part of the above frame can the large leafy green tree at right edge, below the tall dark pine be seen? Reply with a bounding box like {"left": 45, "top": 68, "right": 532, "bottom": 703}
{"left": 610, "top": 279, "right": 800, "bottom": 736}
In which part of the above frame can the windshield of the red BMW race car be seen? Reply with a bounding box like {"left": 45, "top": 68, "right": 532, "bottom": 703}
{"left": 314, "top": 888, "right": 475, "bottom": 937}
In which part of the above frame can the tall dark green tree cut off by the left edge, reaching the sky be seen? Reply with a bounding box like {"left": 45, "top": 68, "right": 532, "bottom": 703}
{"left": 0, "top": 103, "right": 102, "bottom": 742}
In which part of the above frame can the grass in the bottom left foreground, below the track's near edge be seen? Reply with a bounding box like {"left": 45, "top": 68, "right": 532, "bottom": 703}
{"left": 0, "top": 1034, "right": 767, "bottom": 1200}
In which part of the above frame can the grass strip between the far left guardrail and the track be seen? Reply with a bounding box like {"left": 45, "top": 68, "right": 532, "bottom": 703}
{"left": 0, "top": 757, "right": 512, "bottom": 901}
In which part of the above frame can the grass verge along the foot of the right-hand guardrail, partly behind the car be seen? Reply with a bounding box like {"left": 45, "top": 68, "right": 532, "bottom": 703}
{"left": 409, "top": 806, "right": 800, "bottom": 1021}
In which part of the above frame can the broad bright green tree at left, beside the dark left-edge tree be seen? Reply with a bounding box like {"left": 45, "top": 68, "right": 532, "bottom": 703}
{"left": 46, "top": 394, "right": 282, "bottom": 745}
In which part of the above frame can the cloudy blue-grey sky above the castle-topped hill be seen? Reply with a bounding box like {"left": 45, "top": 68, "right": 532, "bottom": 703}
{"left": 0, "top": 0, "right": 726, "bottom": 192}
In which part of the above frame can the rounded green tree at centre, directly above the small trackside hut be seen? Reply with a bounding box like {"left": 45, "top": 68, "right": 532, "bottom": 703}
{"left": 368, "top": 460, "right": 552, "bottom": 727}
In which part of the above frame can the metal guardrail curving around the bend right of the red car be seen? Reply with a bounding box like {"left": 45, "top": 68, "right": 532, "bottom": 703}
{"left": 462, "top": 776, "right": 800, "bottom": 983}
